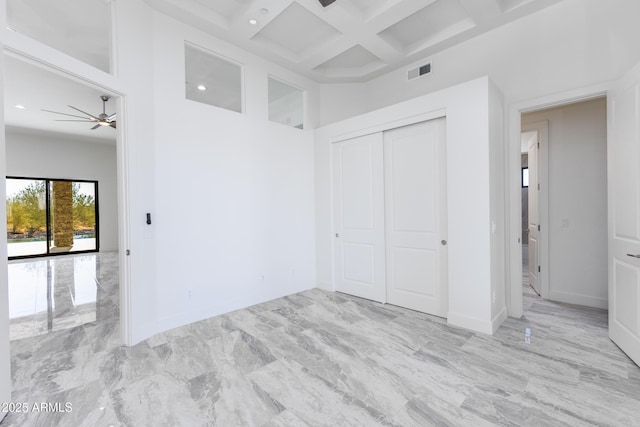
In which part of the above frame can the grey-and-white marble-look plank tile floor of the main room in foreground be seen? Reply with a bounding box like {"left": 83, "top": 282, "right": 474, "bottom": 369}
{"left": 2, "top": 270, "right": 640, "bottom": 427}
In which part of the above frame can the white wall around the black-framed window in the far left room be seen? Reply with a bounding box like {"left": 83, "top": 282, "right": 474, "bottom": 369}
{"left": 6, "top": 129, "right": 118, "bottom": 251}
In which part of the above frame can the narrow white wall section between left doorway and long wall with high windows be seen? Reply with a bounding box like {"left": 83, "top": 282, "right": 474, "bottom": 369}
{"left": 111, "top": 0, "right": 162, "bottom": 344}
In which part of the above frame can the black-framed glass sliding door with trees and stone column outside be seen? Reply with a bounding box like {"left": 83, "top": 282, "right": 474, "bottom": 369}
{"left": 6, "top": 177, "right": 100, "bottom": 259}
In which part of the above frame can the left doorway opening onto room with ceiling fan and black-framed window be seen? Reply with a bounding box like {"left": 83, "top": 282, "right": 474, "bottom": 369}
{"left": 4, "top": 52, "right": 127, "bottom": 343}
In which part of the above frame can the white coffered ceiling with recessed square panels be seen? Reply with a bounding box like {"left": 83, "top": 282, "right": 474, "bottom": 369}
{"left": 146, "top": 0, "right": 561, "bottom": 82}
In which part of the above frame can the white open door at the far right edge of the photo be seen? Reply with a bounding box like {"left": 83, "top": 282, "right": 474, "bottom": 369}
{"left": 608, "top": 64, "right": 640, "bottom": 365}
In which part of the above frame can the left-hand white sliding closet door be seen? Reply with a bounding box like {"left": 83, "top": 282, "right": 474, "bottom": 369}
{"left": 333, "top": 133, "right": 385, "bottom": 302}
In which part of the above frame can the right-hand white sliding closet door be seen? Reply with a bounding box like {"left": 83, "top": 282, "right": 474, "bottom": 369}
{"left": 384, "top": 119, "right": 448, "bottom": 317}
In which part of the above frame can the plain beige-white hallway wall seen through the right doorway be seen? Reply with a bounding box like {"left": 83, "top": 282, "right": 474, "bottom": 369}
{"left": 522, "top": 98, "right": 608, "bottom": 308}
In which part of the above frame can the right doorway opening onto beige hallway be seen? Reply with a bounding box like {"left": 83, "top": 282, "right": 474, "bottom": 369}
{"left": 510, "top": 93, "right": 608, "bottom": 315}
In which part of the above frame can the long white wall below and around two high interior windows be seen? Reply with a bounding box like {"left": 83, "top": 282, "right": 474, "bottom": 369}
{"left": 153, "top": 13, "right": 317, "bottom": 330}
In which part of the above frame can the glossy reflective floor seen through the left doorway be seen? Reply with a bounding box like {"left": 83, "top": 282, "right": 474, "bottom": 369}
{"left": 8, "top": 252, "right": 119, "bottom": 340}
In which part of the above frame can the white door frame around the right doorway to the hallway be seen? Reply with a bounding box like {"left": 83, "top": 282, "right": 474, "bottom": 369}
{"left": 505, "top": 82, "right": 613, "bottom": 318}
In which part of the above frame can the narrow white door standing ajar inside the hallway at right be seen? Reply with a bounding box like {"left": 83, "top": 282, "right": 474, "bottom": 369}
{"left": 527, "top": 131, "right": 540, "bottom": 295}
